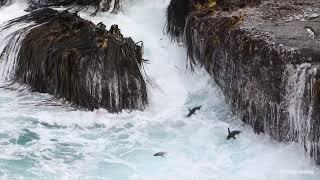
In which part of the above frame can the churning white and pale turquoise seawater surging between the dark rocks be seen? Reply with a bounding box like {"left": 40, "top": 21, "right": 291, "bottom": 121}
{"left": 0, "top": 0, "right": 320, "bottom": 180}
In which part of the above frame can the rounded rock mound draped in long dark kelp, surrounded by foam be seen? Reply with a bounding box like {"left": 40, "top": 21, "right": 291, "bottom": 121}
{"left": 0, "top": 9, "right": 148, "bottom": 112}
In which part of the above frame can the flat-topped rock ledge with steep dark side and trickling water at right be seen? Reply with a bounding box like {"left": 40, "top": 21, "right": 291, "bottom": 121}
{"left": 168, "top": 0, "right": 320, "bottom": 164}
